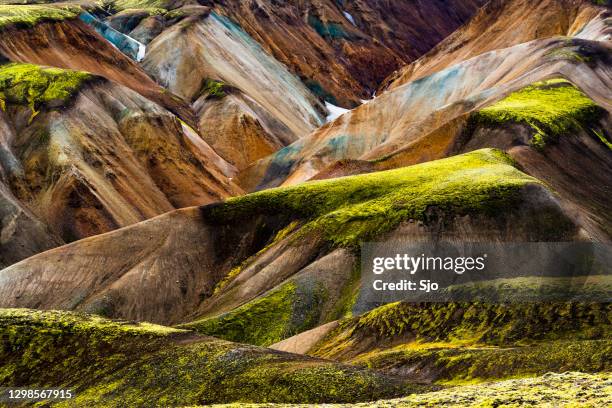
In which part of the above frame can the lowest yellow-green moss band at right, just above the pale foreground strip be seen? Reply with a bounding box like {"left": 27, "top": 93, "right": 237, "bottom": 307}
{"left": 350, "top": 340, "right": 612, "bottom": 385}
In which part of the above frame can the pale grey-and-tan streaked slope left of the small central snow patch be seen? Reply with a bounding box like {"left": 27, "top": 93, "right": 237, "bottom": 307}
{"left": 143, "top": 12, "right": 324, "bottom": 150}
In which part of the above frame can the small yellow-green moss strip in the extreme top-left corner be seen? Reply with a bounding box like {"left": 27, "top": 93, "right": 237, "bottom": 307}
{"left": 0, "top": 4, "right": 81, "bottom": 30}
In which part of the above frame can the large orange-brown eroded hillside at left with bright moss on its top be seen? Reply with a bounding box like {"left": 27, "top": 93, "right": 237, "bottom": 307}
{"left": 0, "top": 64, "right": 241, "bottom": 262}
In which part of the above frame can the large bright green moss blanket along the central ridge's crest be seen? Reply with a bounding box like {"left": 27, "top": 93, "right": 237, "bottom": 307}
{"left": 205, "top": 149, "right": 539, "bottom": 246}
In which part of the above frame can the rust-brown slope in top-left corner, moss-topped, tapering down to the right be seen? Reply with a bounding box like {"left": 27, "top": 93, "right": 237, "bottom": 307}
{"left": 0, "top": 5, "right": 195, "bottom": 126}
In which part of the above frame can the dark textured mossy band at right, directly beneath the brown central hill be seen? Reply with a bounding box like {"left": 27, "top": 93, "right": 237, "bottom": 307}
{"left": 321, "top": 302, "right": 612, "bottom": 354}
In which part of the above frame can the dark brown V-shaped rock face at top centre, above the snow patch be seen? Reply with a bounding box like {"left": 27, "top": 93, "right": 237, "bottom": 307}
{"left": 210, "top": 0, "right": 485, "bottom": 107}
